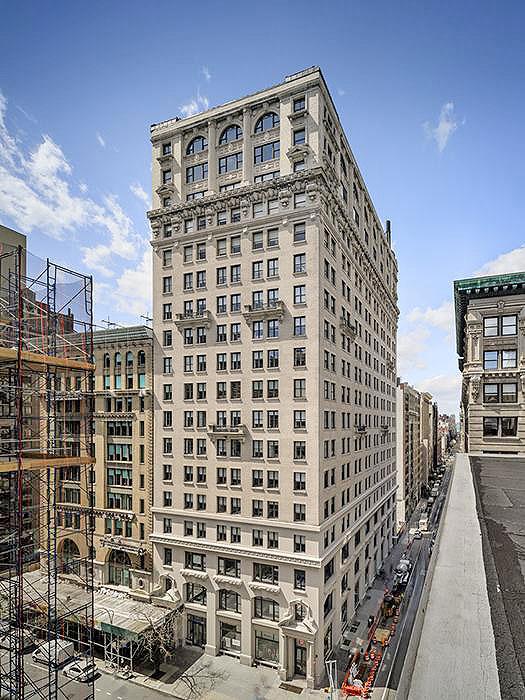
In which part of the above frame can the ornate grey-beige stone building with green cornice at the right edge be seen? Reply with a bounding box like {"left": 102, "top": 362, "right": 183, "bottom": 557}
{"left": 454, "top": 272, "right": 525, "bottom": 454}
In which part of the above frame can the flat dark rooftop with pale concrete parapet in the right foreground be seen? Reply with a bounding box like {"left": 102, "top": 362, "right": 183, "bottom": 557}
{"left": 409, "top": 454, "right": 525, "bottom": 700}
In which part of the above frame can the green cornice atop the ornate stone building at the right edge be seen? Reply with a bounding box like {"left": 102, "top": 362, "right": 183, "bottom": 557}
{"left": 454, "top": 272, "right": 525, "bottom": 357}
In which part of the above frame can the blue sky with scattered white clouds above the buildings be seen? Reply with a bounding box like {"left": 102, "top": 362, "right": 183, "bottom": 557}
{"left": 0, "top": 0, "right": 525, "bottom": 411}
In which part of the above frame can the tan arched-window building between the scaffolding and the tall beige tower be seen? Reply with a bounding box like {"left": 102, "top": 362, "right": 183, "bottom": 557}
{"left": 58, "top": 326, "right": 153, "bottom": 598}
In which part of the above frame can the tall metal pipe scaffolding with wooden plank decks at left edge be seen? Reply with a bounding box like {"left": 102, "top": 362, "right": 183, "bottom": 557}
{"left": 0, "top": 245, "right": 94, "bottom": 700}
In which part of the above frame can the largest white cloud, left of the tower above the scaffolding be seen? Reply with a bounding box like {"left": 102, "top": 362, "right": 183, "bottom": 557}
{"left": 0, "top": 86, "right": 143, "bottom": 276}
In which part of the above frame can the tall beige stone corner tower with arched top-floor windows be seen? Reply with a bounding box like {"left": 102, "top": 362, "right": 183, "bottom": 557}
{"left": 149, "top": 68, "right": 398, "bottom": 686}
